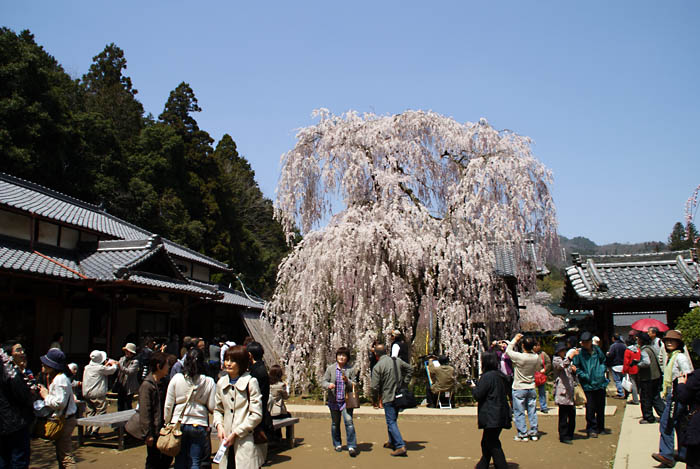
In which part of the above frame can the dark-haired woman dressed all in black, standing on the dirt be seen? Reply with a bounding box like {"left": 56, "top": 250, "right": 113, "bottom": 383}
{"left": 472, "top": 352, "right": 511, "bottom": 469}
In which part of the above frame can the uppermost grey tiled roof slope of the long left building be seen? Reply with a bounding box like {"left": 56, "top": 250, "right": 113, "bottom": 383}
{"left": 0, "top": 173, "right": 230, "bottom": 270}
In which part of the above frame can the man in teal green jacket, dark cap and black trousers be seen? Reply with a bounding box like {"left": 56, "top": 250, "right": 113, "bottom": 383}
{"left": 574, "top": 331, "right": 610, "bottom": 438}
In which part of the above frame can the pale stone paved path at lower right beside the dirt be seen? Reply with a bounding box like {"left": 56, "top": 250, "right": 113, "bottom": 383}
{"left": 613, "top": 404, "right": 664, "bottom": 469}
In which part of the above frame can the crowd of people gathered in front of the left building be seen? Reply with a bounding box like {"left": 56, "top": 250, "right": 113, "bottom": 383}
{"left": 0, "top": 334, "right": 290, "bottom": 469}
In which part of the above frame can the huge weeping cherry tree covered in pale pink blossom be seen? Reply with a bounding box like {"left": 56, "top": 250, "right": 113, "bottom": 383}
{"left": 264, "top": 109, "right": 556, "bottom": 385}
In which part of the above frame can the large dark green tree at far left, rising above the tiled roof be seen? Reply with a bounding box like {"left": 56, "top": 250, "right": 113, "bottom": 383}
{"left": 0, "top": 28, "right": 93, "bottom": 196}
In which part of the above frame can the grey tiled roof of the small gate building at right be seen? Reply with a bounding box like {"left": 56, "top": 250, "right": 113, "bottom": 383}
{"left": 566, "top": 256, "right": 700, "bottom": 301}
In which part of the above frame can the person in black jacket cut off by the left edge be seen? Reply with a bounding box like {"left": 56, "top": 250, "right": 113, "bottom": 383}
{"left": 0, "top": 349, "right": 33, "bottom": 468}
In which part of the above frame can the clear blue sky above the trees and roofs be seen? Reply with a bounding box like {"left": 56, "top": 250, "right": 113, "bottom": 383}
{"left": 0, "top": 0, "right": 700, "bottom": 244}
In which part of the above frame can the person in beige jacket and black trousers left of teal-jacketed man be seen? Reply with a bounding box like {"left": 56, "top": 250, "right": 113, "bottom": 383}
{"left": 552, "top": 342, "right": 578, "bottom": 445}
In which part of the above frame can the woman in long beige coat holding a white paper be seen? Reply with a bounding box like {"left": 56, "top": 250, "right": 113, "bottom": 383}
{"left": 214, "top": 345, "right": 265, "bottom": 469}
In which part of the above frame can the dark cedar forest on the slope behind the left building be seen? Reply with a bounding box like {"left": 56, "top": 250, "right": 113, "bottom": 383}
{"left": 0, "top": 28, "right": 289, "bottom": 297}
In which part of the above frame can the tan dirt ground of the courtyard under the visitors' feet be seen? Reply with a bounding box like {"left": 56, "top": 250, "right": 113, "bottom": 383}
{"left": 31, "top": 399, "right": 624, "bottom": 469}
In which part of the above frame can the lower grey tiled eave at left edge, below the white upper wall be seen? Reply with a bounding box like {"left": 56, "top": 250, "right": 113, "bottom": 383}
{"left": 0, "top": 237, "right": 80, "bottom": 280}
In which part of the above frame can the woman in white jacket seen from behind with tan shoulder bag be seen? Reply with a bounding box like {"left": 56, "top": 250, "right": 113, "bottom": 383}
{"left": 163, "top": 348, "right": 216, "bottom": 469}
